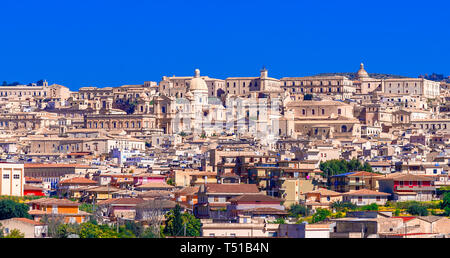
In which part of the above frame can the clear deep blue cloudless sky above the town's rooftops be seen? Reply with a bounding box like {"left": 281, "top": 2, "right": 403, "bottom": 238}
{"left": 0, "top": 0, "right": 450, "bottom": 90}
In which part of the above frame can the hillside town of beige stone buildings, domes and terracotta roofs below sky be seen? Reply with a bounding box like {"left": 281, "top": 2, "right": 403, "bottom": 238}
{"left": 0, "top": 64, "right": 450, "bottom": 238}
